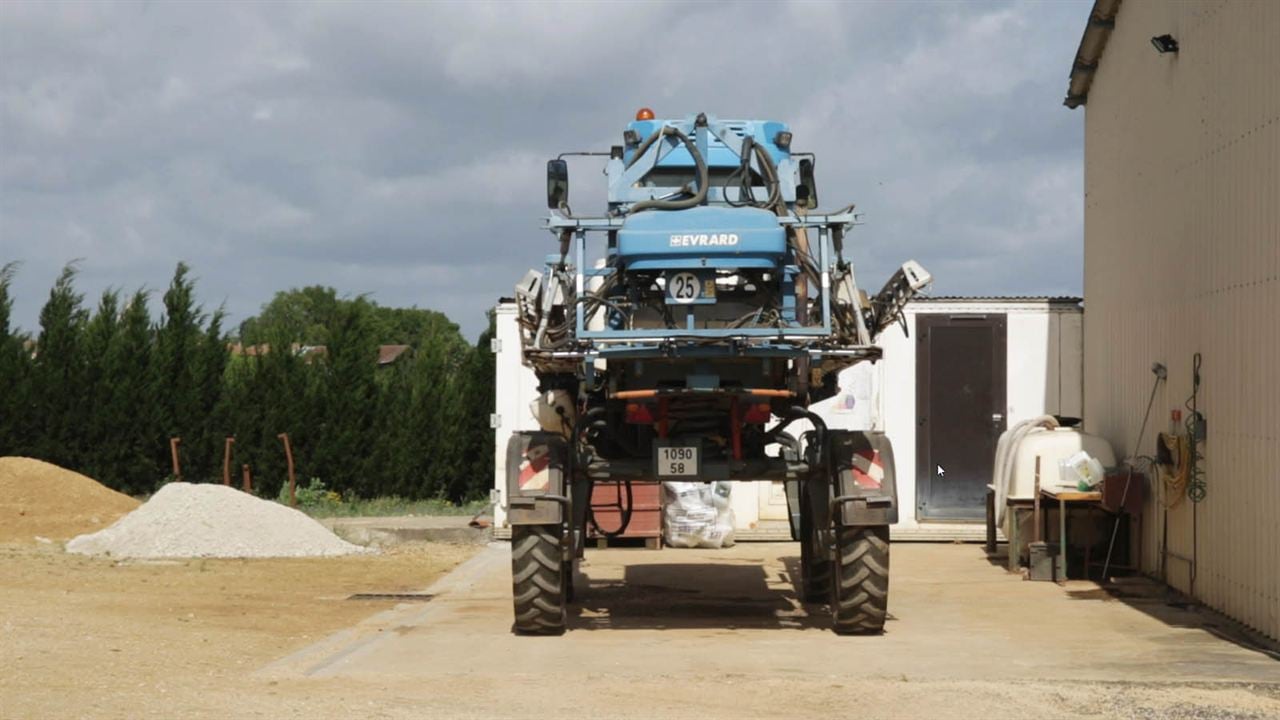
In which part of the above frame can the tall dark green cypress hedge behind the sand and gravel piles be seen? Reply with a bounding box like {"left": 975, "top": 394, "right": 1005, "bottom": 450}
{"left": 0, "top": 263, "right": 494, "bottom": 502}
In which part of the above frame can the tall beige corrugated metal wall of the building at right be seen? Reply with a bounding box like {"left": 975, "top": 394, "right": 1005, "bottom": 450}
{"left": 1084, "top": 0, "right": 1280, "bottom": 638}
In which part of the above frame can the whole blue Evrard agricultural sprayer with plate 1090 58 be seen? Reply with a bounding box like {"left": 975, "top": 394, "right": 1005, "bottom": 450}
{"left": 507, "top": 110, "right": 931, "bottom": 634}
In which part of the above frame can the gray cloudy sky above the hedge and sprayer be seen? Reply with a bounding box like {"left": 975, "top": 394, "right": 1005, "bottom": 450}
{"left": 0, "top": 0, "right": 1089, "bottom": 337}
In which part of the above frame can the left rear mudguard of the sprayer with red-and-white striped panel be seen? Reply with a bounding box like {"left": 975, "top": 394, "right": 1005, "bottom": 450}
{"left": 507, "top": 432, "right": 568, "bottom": 525}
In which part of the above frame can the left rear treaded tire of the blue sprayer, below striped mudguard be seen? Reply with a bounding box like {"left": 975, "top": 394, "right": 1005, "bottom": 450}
{"left": 511, "top": 525, "right": 566, "bottom": 635}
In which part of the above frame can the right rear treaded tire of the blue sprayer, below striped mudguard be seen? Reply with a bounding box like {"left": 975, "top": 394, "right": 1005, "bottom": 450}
{"left": 831, "top": 525, "right": 888, "bottom": 634}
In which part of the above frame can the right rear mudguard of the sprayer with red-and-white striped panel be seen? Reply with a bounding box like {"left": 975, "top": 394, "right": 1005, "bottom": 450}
{"left": 831, "top": 430, "right": 897, "bottom": 527}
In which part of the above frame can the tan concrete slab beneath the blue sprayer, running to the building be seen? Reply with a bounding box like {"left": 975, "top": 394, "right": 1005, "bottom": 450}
{"left": 260, "top": 543, "right": 1280, "bottom": 717}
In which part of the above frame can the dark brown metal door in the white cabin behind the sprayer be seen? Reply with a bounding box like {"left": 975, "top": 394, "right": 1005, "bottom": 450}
{"left": 915, "top": 313, "right": 1005, "bottom": 521}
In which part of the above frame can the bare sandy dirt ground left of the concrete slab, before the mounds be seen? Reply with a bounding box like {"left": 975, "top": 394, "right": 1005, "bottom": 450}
{"left": 0, "top": 544, "right": 476, "bottom": 719}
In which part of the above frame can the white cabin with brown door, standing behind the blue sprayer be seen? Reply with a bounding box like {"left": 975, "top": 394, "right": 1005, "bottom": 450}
{"left": 490, "top": 297, "right": 1083, "bottom": 539}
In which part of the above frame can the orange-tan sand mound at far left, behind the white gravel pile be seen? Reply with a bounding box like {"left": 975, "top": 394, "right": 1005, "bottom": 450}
{"left": 0, "top": 457, "right": 138, "bottom": 542}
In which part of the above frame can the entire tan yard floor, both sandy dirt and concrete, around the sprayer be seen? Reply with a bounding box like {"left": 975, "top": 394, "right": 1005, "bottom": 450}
{"left": 0, "top": 535, "right": 1280, "bottom": 720}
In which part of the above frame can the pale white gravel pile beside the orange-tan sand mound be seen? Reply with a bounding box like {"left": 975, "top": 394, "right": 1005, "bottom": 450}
{"left": 67, "top": 483, "right": 370, "bottom": 557}
